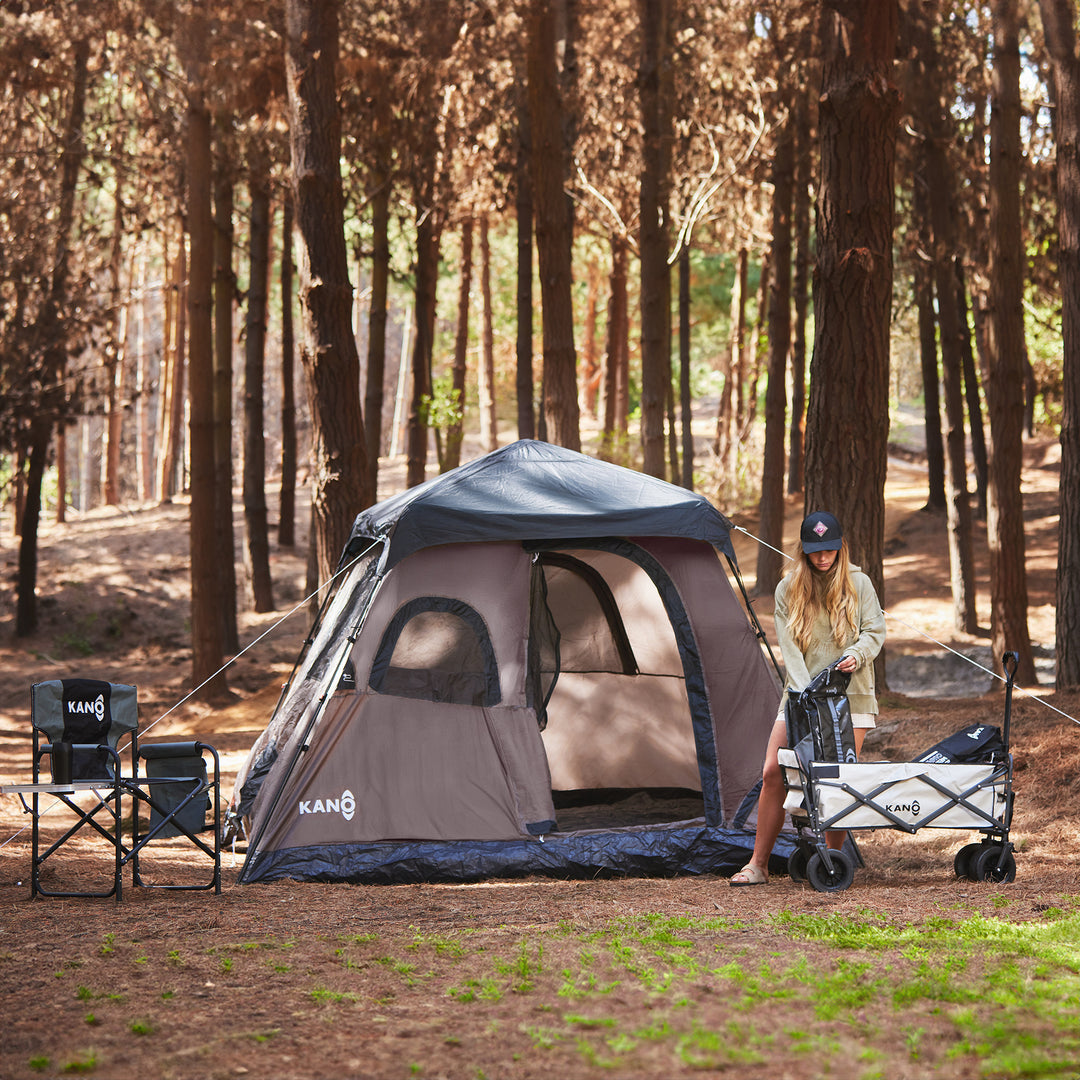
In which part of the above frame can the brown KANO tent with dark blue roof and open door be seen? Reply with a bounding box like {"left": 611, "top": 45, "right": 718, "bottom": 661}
{"left": 229, "top": 440, "right": 783, "bottom": 882}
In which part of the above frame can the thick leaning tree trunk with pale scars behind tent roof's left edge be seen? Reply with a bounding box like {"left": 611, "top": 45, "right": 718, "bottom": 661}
{"left": 285, "top": 0, "right": 374, "bottom": 581}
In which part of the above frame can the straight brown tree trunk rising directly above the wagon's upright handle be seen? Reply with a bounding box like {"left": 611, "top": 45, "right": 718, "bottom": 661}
{"left": 986, "top": 0, "right": 1036, "bottom": 684}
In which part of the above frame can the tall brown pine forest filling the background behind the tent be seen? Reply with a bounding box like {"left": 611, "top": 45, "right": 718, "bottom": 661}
{"left": 0, "top": 0, "right": 1080, "bottom": 688}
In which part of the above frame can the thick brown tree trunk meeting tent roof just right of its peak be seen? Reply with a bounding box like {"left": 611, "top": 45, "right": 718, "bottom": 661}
{"left": 528, "top": 0, "right": 581, "bottom": 450}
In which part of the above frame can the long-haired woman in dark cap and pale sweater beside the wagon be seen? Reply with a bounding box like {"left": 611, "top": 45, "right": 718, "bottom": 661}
{"left": 729, "top": 512, "right": 885, "bottom": 886}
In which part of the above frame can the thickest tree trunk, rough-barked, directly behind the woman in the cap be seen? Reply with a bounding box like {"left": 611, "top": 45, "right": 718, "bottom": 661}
{"left": 806, "top": 0, "right": 900, "bottom": 603}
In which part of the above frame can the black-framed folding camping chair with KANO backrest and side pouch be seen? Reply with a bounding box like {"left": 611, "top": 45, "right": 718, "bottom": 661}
{"left": 3, "top": 678, "right": 221, "bottom": 901}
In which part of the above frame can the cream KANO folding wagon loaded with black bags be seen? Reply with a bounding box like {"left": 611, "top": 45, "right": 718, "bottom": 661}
{"left": 779, "top": 652, "right": 1020, "bottom": 892}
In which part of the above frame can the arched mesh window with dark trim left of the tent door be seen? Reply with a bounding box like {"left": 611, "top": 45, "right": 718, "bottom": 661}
{"left": 370, "top": 596, "right": 501, "bottom": 705}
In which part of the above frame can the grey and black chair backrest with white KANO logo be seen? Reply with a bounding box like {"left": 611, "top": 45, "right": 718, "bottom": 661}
{"left": 30, "top": 678, "right": 138, "bottom": 780}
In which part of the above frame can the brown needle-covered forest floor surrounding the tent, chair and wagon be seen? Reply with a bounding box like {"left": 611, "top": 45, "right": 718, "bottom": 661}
{"left": 0, "top": 425, "right": 1080, "bottom": 1080}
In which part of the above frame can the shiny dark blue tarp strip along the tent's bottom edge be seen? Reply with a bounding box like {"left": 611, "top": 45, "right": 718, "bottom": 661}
{"left": 238, "top": 819, "right": 795, "bottom": 885}
